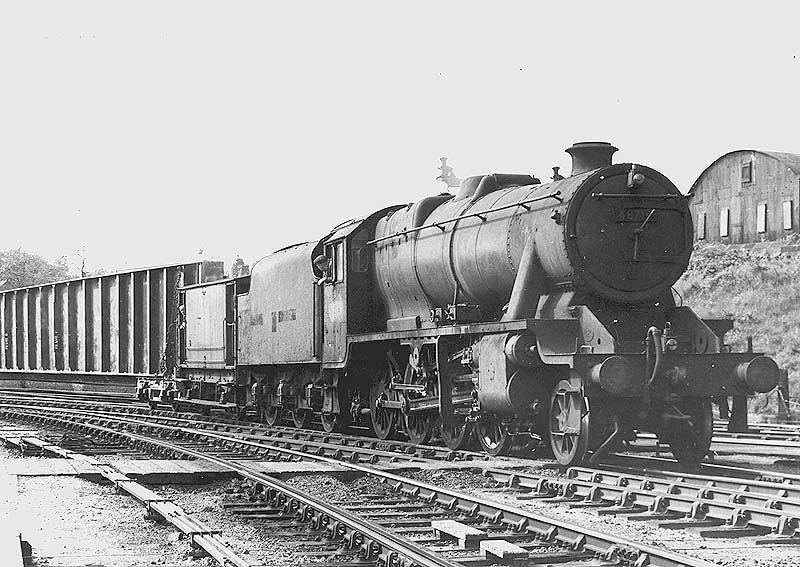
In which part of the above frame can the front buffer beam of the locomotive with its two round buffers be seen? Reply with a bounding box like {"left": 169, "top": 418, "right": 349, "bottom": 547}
{"left": 573, "top": 353, "right": 780, "bottom": 398}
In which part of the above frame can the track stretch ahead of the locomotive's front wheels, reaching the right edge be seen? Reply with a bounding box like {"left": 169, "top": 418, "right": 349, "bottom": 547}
{"left": 485, "top": 467, "right": 800, "bottom": 545}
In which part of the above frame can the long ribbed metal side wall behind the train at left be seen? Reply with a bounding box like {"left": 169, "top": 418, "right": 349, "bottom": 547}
{"left": 0, "top": 262, "right": 223, "bottom": 374}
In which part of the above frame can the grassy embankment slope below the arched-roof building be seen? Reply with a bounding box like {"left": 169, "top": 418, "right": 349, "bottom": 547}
{"left": 675, "top": 242, "right": 800, "bottom": 417}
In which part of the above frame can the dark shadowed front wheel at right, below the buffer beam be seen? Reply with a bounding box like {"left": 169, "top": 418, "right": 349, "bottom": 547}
{"left": 663, "top": 399, "right": 714, "bottom": 467}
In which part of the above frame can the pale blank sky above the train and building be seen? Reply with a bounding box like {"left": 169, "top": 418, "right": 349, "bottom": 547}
{"left": 0, "top": 0, "right": 800, "bottom": 278}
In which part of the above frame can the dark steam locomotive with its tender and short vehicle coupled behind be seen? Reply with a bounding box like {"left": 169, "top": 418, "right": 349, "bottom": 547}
{"left": 139, "top": 142, "right": 779, "bottom": 465}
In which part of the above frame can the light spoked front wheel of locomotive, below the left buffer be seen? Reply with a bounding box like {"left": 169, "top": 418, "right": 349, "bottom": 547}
{"left": 549, "top": 380, "right": 589, "bottom": 466}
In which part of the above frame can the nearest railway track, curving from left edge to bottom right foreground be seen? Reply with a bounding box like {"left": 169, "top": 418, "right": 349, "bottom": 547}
{"left": 0, "top": 405, "right": 710, "bottom": 566}
